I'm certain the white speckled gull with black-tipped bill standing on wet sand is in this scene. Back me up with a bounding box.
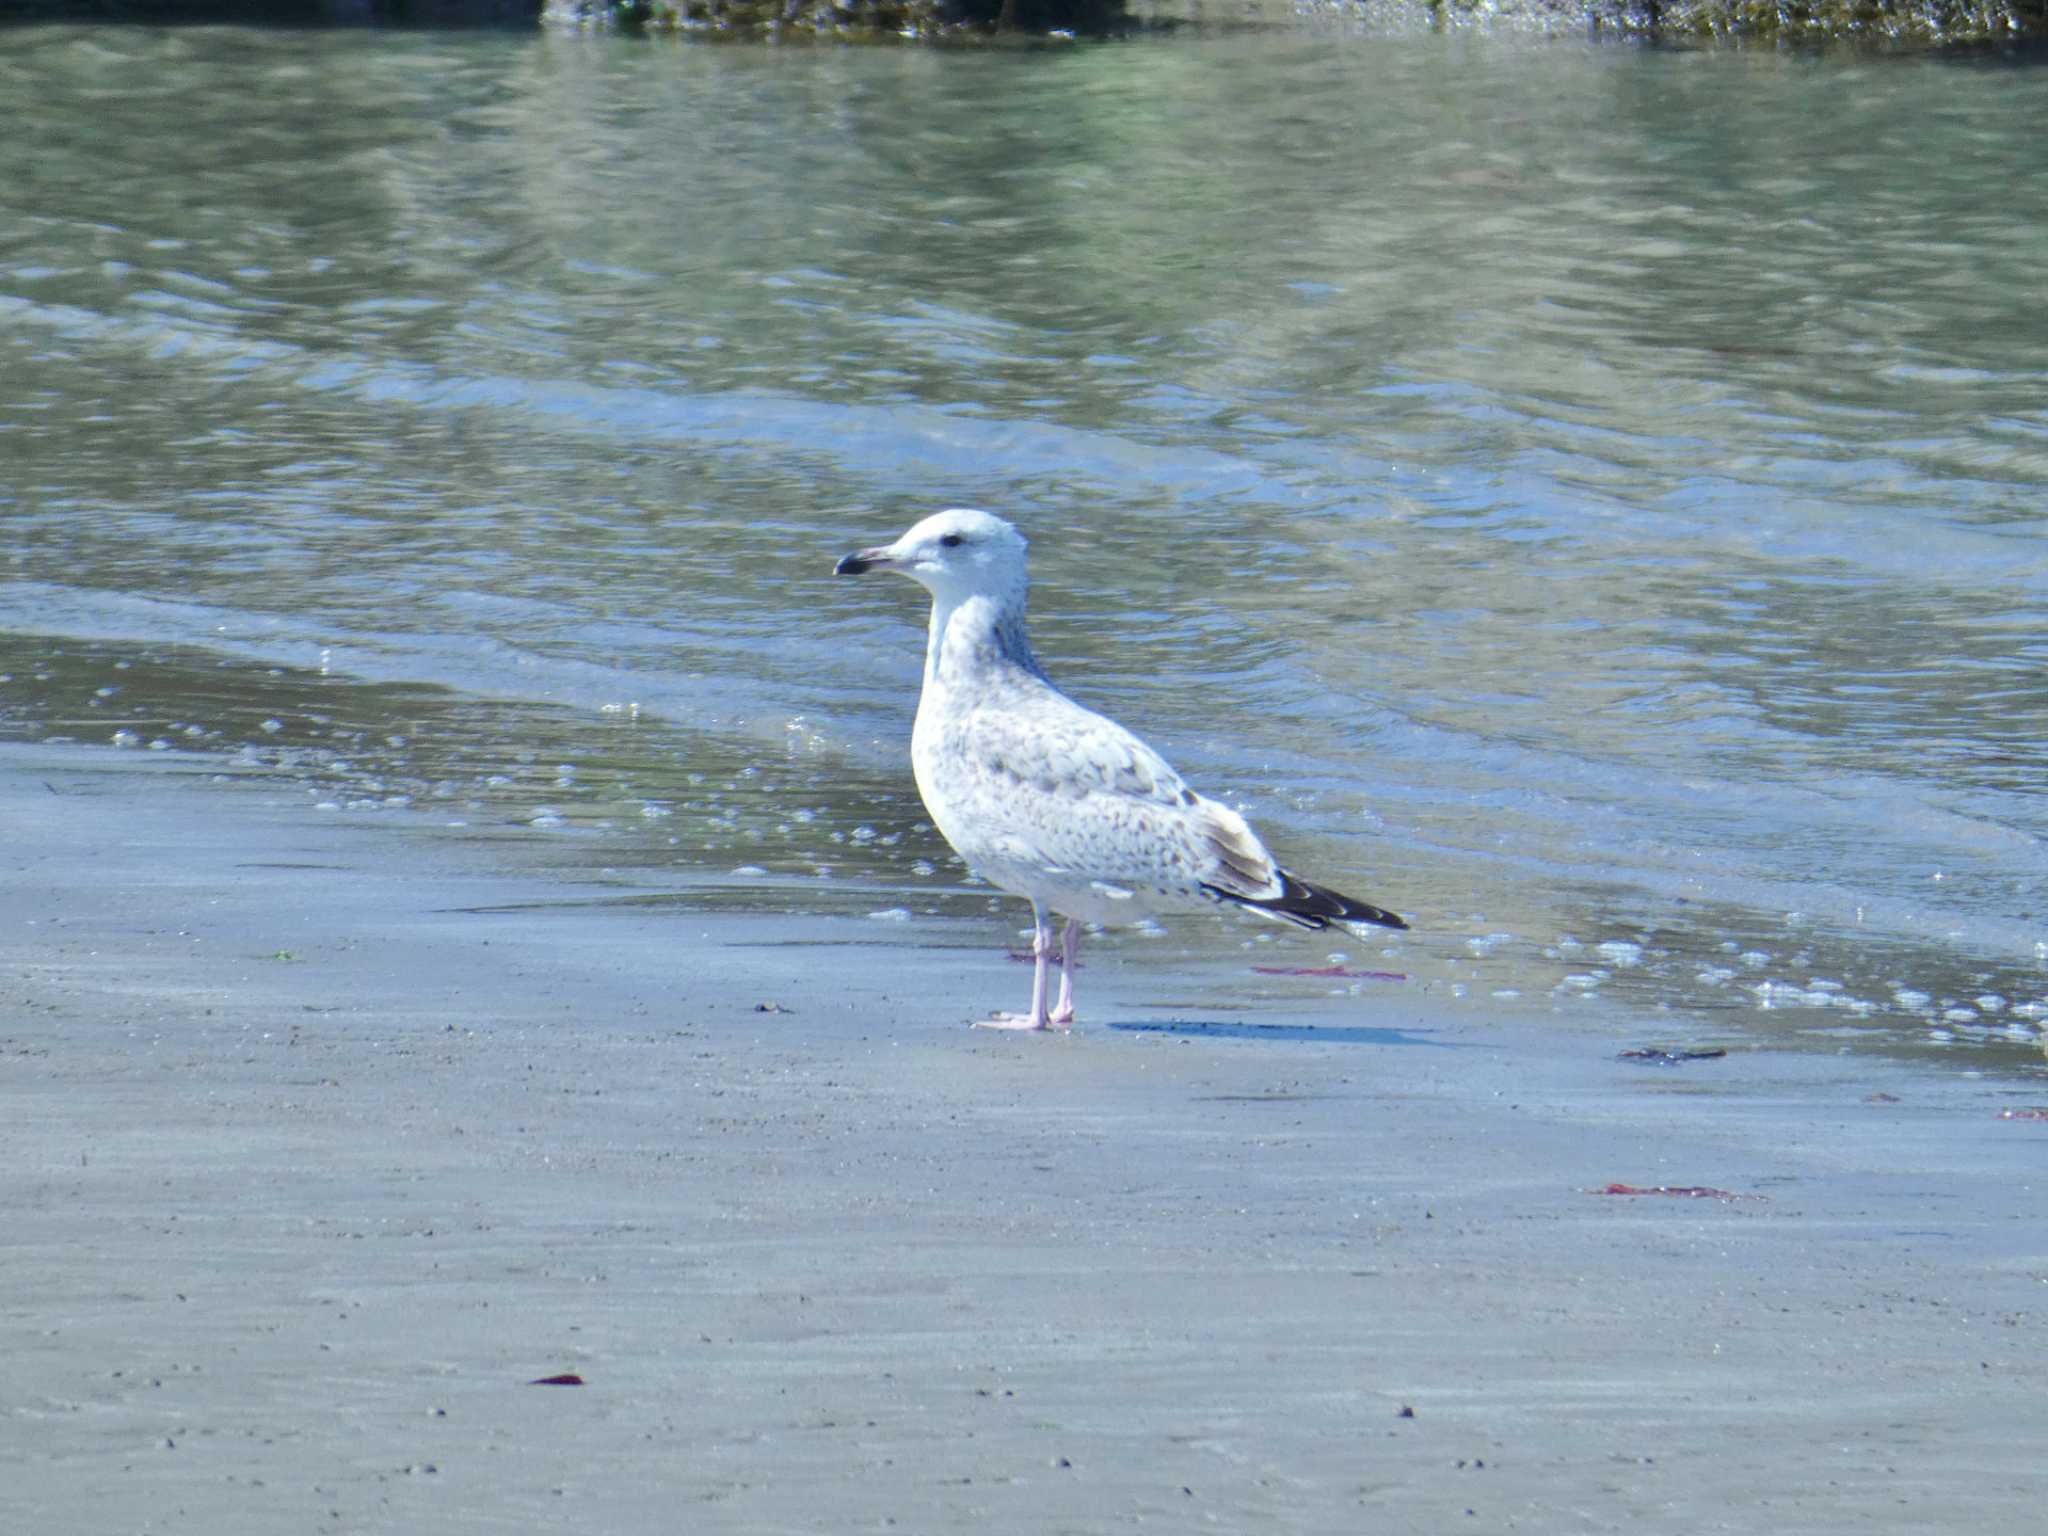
[834,508,1407,1030]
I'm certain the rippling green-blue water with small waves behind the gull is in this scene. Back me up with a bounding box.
[0,27,2048,1065]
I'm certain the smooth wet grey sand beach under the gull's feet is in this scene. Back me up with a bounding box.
[0,748,2048,1536]
